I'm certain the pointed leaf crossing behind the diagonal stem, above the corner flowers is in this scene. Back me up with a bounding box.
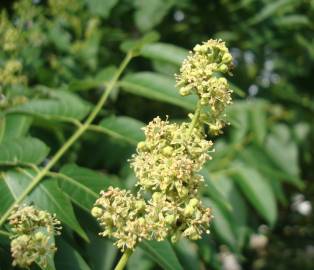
[2,169,88,240]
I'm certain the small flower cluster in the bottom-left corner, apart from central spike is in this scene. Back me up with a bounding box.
[9,206,61,268]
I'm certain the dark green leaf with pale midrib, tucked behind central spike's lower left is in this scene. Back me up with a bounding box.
[57,164,115,212]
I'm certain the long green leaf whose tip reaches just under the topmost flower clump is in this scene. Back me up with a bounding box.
[120,72,196,110]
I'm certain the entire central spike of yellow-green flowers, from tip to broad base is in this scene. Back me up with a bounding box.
[92,40,231,251]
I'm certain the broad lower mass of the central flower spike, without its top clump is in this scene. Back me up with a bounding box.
[92,117,212,251]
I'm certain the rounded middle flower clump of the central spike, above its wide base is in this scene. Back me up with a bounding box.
[131,117,212,198]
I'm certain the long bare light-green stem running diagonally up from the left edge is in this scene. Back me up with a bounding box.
[0,51,133,226]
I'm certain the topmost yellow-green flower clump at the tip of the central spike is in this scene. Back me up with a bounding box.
[176,39,232,135]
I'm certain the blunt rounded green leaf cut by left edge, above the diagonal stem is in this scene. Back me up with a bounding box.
[0,137,49,165]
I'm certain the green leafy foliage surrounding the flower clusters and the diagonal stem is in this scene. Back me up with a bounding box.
[0,0,314,270]
